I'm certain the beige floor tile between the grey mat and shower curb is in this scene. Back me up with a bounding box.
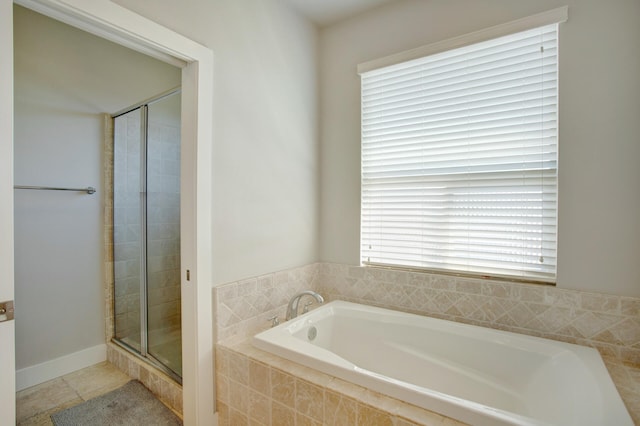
[62,361,131,401]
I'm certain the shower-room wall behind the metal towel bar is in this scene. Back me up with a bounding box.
[14,6,180,369]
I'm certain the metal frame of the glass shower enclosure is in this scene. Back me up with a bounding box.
[111,87,182,384]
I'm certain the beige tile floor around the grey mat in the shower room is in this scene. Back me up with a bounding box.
[16,361,131,426]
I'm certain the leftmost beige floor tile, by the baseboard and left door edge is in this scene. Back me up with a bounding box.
[16,378,82,422]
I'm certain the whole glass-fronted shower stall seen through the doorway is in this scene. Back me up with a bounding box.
[112,89,182,382]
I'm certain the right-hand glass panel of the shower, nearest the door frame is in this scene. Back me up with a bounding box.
[147,94,182,376]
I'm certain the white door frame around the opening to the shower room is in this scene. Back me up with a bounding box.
[0,0,215,424]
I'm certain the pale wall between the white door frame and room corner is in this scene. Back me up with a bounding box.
[115,0,318,285]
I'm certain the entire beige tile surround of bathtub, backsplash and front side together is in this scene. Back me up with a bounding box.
[213,263,640,425]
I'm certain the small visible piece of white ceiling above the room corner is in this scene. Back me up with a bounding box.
[287,0,397,27]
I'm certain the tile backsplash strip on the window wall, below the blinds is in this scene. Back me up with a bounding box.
[318,264,640,365]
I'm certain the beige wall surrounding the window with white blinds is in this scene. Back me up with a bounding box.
[320,0,640,296]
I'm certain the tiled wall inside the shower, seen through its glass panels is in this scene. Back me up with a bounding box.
[114,114,180,349]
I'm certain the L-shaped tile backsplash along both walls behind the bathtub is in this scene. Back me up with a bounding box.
[214,263,640,365]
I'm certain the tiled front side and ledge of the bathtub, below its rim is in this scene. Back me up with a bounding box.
[216,343,461,426]
